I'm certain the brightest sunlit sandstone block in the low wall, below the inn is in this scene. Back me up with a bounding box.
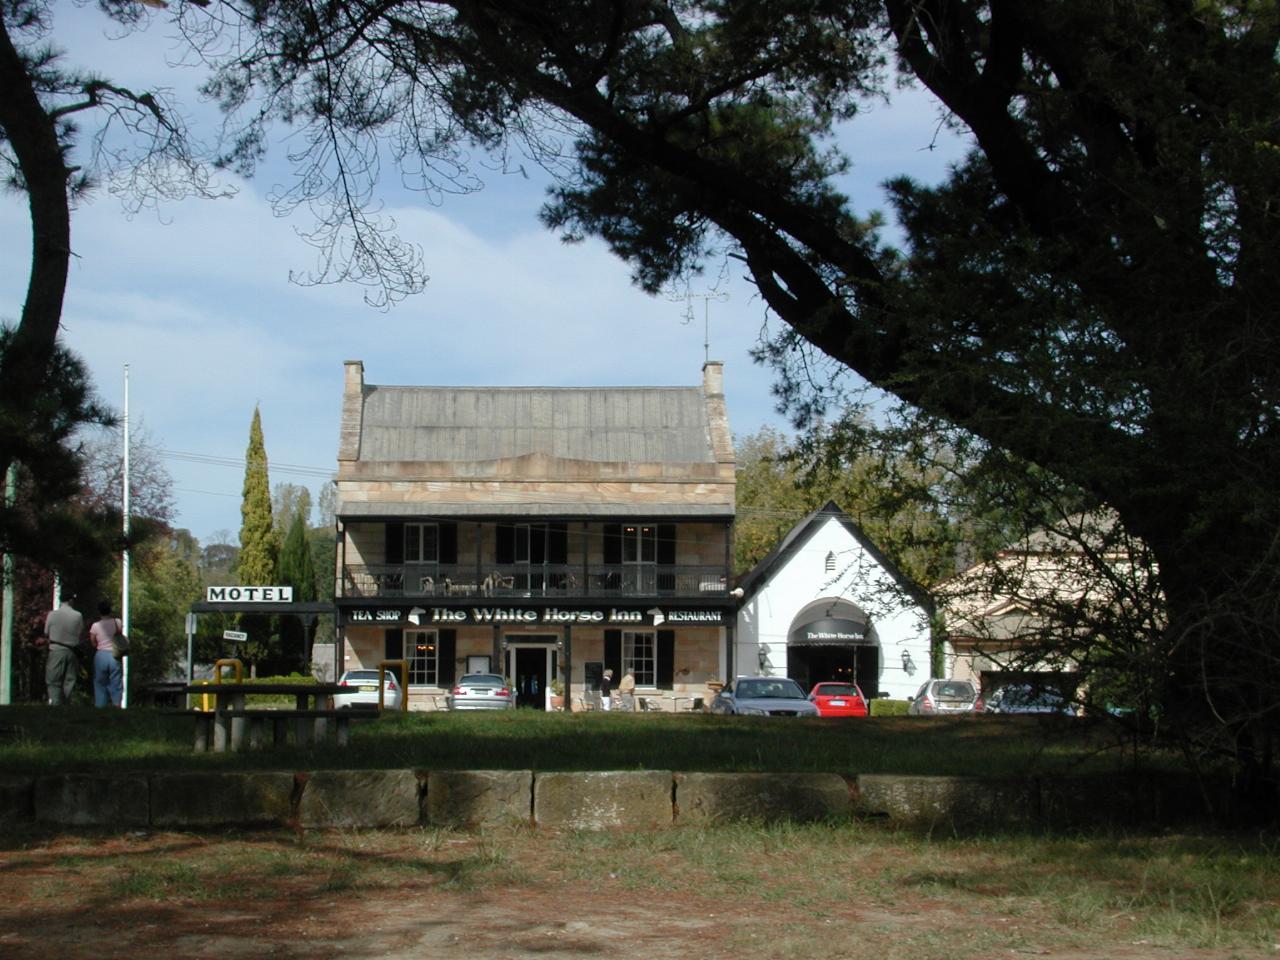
[534,771,675,829]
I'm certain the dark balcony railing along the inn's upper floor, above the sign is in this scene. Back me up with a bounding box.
[342,563,728,598]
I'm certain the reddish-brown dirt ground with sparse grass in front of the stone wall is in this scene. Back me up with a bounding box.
[0,833,1280,960]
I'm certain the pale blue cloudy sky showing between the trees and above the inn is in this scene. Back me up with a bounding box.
[0,3,961,541]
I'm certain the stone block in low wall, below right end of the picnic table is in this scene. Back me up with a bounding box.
[298,771,421,827]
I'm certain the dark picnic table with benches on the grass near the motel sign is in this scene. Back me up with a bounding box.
[172,682,378,753]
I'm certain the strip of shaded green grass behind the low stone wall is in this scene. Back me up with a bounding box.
[0,707,1174,777]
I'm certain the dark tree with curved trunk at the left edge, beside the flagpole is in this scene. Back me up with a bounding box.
[0,0,211,570]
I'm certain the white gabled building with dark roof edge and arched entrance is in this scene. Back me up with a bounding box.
[733,502,933,699]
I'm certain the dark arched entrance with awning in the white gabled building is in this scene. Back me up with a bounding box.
[787,598,881,698]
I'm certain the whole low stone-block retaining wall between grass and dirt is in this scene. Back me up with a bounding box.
[0,769,1218,829]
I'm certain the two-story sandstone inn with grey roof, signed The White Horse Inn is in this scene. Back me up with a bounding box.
[337,361,735,709]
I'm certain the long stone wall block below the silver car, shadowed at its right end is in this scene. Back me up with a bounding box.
[856,773,1039,828]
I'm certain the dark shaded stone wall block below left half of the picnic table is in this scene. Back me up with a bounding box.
[151,771,294,827]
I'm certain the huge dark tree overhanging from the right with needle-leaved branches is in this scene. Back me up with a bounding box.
[186,0,1280,803]
